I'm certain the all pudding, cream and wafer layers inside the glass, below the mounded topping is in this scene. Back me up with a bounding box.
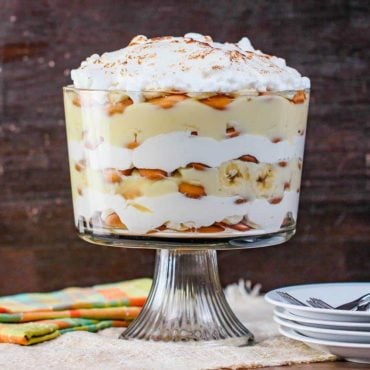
[65,89,308,237]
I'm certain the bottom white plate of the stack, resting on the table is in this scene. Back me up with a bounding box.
[279,326,370,364]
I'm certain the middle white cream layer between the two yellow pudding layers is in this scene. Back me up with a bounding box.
[68,132,304,172]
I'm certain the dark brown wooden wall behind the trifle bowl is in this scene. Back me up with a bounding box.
[0,0,370,294]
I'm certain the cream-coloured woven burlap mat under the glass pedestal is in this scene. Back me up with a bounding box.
[0,282,336,370]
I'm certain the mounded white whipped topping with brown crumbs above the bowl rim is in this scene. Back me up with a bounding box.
[71,33,310,96]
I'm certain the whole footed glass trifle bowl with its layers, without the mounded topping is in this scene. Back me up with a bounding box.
[64,32,309,345]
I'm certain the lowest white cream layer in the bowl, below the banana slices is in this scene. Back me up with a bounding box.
[74,189,299,234]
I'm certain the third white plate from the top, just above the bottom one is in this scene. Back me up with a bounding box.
[274,316,370,345]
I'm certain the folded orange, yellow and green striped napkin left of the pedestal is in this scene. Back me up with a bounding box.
[0,278,152,345]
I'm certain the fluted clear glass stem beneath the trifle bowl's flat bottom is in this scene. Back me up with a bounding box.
[122,248,253,345]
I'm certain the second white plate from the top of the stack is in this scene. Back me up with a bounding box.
[274,307,370,332]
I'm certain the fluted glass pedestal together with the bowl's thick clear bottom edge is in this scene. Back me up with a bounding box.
[79,228,295,346]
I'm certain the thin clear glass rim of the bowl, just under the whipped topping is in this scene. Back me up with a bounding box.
[63,85,311,97]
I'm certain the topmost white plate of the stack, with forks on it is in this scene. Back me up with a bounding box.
[265,283,370,323]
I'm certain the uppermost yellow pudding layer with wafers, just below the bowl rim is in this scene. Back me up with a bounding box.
[65,90,308,148]
